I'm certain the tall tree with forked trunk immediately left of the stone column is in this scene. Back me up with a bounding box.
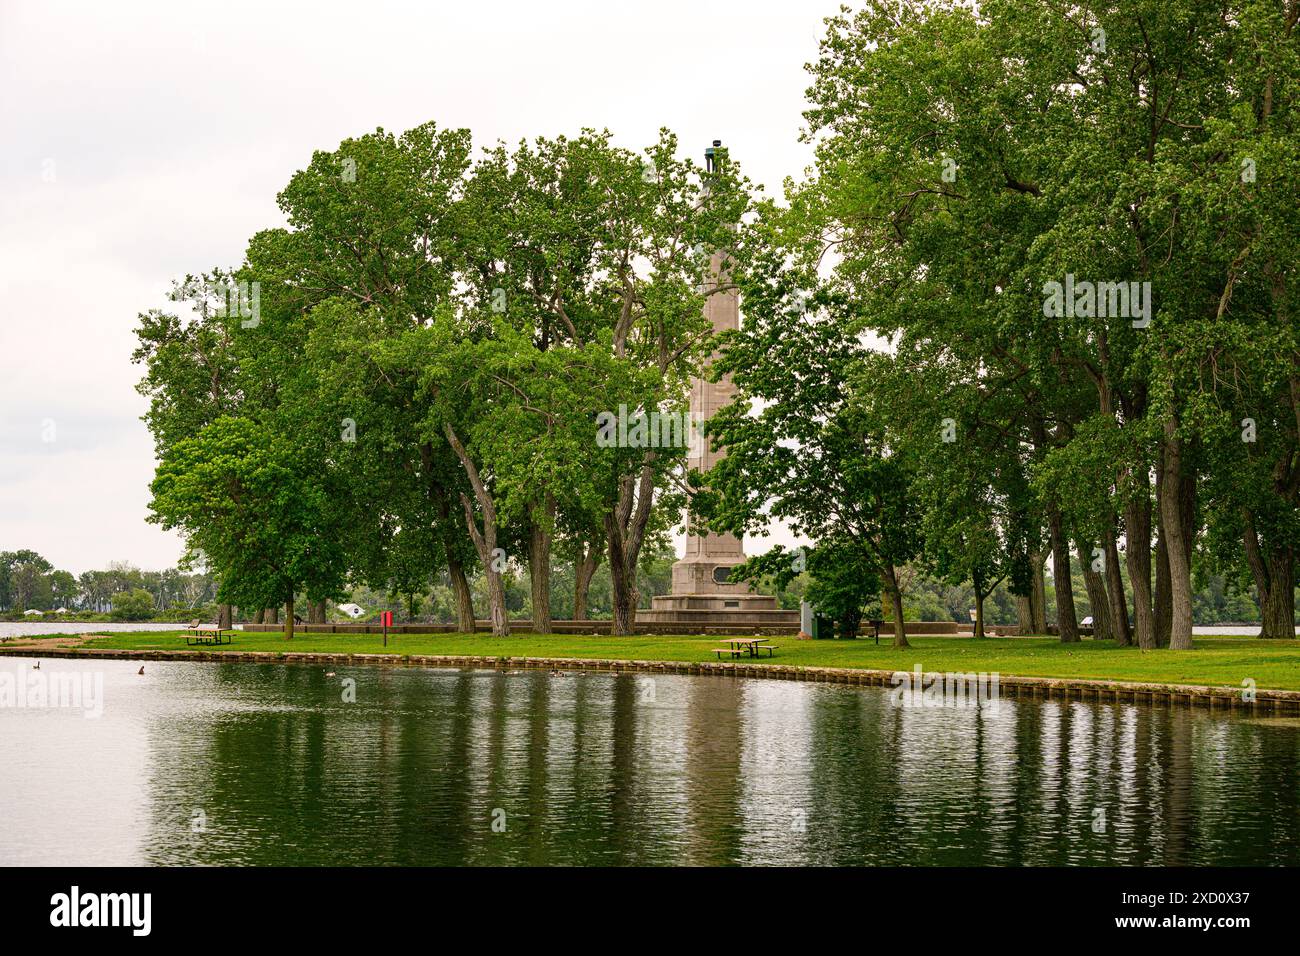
[463,130,750,633]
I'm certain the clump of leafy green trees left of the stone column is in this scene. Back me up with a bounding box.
[135,124,751,635]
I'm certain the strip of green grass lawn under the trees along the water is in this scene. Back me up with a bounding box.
[30,631,1300,691]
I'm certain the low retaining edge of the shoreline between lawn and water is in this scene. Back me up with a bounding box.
[0,646,1300,715]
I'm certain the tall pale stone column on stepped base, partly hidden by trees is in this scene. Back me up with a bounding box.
[651,139,776,611]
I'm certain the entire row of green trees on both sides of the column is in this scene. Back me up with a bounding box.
[135,0,1300,648]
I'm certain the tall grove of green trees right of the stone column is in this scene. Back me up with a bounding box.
[710,0,1300,648]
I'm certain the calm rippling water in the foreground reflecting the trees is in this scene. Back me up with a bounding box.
[0,657,1300,865]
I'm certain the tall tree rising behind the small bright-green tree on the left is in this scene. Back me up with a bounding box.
[242,124,475,632]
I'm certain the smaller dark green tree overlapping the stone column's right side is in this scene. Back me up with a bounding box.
[693,252,922,646]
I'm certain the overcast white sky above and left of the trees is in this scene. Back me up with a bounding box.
[0,0,839,572]
